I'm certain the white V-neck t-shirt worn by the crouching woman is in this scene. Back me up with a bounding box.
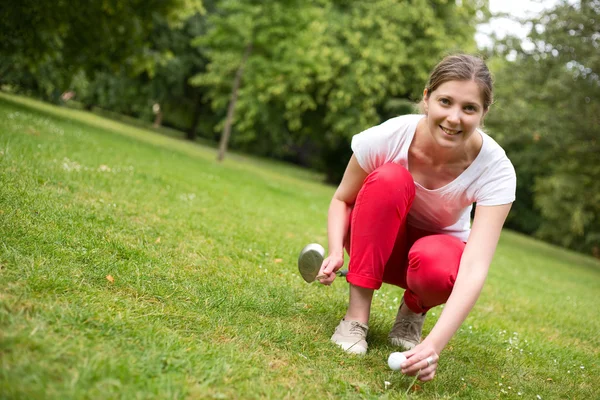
[352,115,517,242]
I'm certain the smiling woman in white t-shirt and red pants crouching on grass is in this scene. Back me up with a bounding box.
[319,55,516,381]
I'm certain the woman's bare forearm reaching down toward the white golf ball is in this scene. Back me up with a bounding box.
[425,265,487,354]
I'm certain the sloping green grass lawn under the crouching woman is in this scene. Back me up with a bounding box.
[0,90,600,399]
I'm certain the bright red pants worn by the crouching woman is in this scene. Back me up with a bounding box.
[345,164,465,312]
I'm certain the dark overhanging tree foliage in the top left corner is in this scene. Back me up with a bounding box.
[0,0,203,99]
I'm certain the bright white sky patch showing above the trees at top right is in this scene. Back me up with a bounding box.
[475,0,559,47]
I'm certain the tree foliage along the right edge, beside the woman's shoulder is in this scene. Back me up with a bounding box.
[488,0,600,255]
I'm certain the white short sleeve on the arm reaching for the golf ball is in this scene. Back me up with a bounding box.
[475,156,517,206]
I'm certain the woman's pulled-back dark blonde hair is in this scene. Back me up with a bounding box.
[420,54,494,111]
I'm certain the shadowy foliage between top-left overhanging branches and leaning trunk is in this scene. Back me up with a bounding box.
[72,14,210,131]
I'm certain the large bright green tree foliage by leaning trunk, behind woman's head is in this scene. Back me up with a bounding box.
[192,0,486,180]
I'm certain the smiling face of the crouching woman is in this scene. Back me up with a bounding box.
[423,80,485,148]
